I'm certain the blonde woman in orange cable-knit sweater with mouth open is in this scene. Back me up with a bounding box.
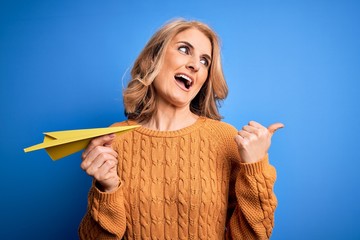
[79,20,283,240]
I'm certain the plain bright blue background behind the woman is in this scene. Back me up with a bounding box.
[0,0,360,239]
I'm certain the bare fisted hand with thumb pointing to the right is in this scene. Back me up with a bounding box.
[235,121,284,163]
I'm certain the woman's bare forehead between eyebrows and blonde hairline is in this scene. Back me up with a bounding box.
[171,28,212,56]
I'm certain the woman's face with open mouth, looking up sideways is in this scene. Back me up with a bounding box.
[153,28,212,107]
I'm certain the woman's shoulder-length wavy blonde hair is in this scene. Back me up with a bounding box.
[123,19,228,122]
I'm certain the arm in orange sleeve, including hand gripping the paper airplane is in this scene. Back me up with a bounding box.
[79,135,126,240]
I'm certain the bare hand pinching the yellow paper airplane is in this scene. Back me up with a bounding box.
[80,134,120,192]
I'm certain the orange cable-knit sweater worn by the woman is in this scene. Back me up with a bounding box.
[79,117,277,240]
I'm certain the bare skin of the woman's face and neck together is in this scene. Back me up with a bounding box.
[141,28,212,131]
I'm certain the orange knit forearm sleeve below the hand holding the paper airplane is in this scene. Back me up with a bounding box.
[79,183,126,240]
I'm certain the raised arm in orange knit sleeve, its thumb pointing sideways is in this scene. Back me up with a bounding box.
[226,121,284,240]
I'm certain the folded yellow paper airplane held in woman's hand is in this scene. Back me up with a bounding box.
[24,125,140,160]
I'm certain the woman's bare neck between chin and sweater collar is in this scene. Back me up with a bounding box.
[142,105,199,131]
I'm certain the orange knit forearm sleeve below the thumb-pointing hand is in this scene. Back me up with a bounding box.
[226,156,277,240]
